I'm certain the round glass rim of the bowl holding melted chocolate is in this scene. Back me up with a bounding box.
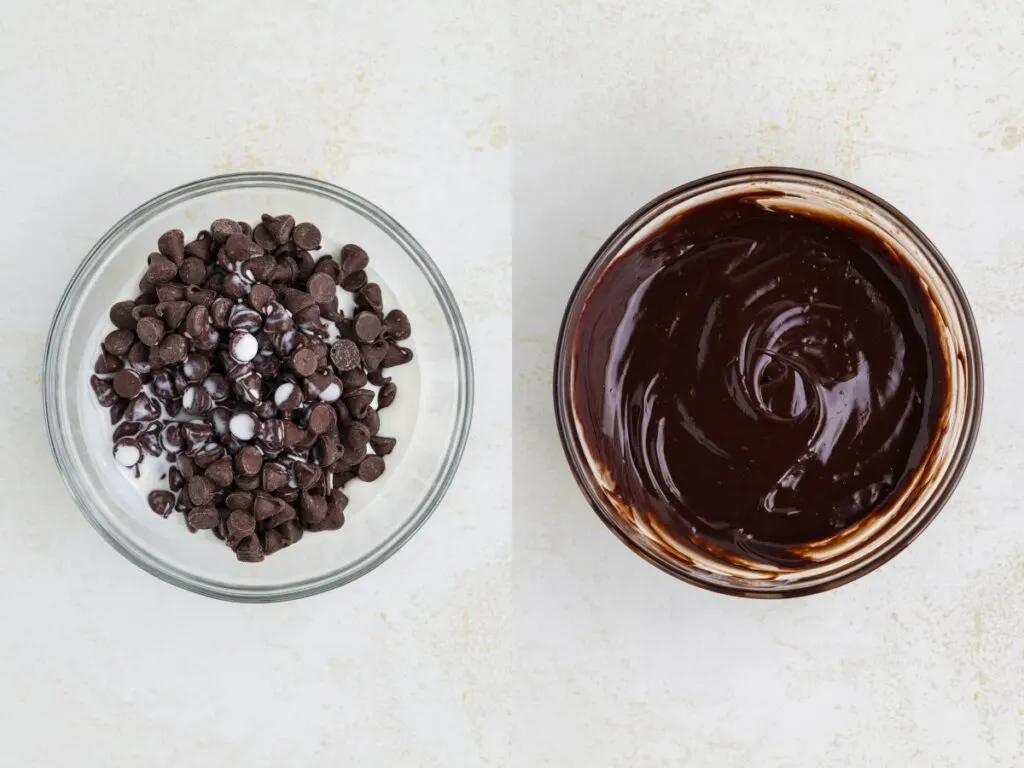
[552,166,985,599]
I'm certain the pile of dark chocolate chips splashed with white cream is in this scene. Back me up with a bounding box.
[91,214,413,562]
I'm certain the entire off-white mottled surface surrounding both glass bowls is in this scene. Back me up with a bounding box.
[0,0,1024,768]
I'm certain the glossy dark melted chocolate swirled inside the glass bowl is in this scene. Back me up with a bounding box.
[572,198,948,566]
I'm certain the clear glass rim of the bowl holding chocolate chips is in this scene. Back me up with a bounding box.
[43,172,474,602]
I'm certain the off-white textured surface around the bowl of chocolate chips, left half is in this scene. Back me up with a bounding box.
[0,0,512,768]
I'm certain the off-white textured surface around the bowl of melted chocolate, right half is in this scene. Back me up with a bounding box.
[520,0,1024,768]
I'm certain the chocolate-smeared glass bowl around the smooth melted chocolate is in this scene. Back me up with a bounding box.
[554,168,983,597]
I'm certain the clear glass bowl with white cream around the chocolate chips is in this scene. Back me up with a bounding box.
[43,173,473,602]
